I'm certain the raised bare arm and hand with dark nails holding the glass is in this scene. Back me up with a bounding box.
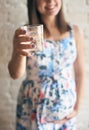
[8,28,33,79]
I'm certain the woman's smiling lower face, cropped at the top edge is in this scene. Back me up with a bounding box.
[36,0,62,16]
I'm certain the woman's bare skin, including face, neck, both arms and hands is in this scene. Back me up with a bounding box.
[8,0,85,124]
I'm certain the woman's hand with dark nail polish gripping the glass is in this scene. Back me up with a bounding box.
[13,28,35,56]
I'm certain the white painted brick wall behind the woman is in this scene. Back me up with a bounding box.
[0,0,89,130]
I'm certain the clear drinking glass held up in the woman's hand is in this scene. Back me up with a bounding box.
[22,24,43,51]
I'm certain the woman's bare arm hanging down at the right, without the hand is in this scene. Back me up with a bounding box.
[74,26,85,111]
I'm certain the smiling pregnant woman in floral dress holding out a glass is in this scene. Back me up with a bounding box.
[8,0,84,130]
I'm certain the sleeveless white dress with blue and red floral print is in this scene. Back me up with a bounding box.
[16,26,77,130]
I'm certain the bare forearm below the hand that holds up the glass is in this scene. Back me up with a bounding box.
[8,53,26,79]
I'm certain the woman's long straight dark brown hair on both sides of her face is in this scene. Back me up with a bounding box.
[27,0,71,33]
